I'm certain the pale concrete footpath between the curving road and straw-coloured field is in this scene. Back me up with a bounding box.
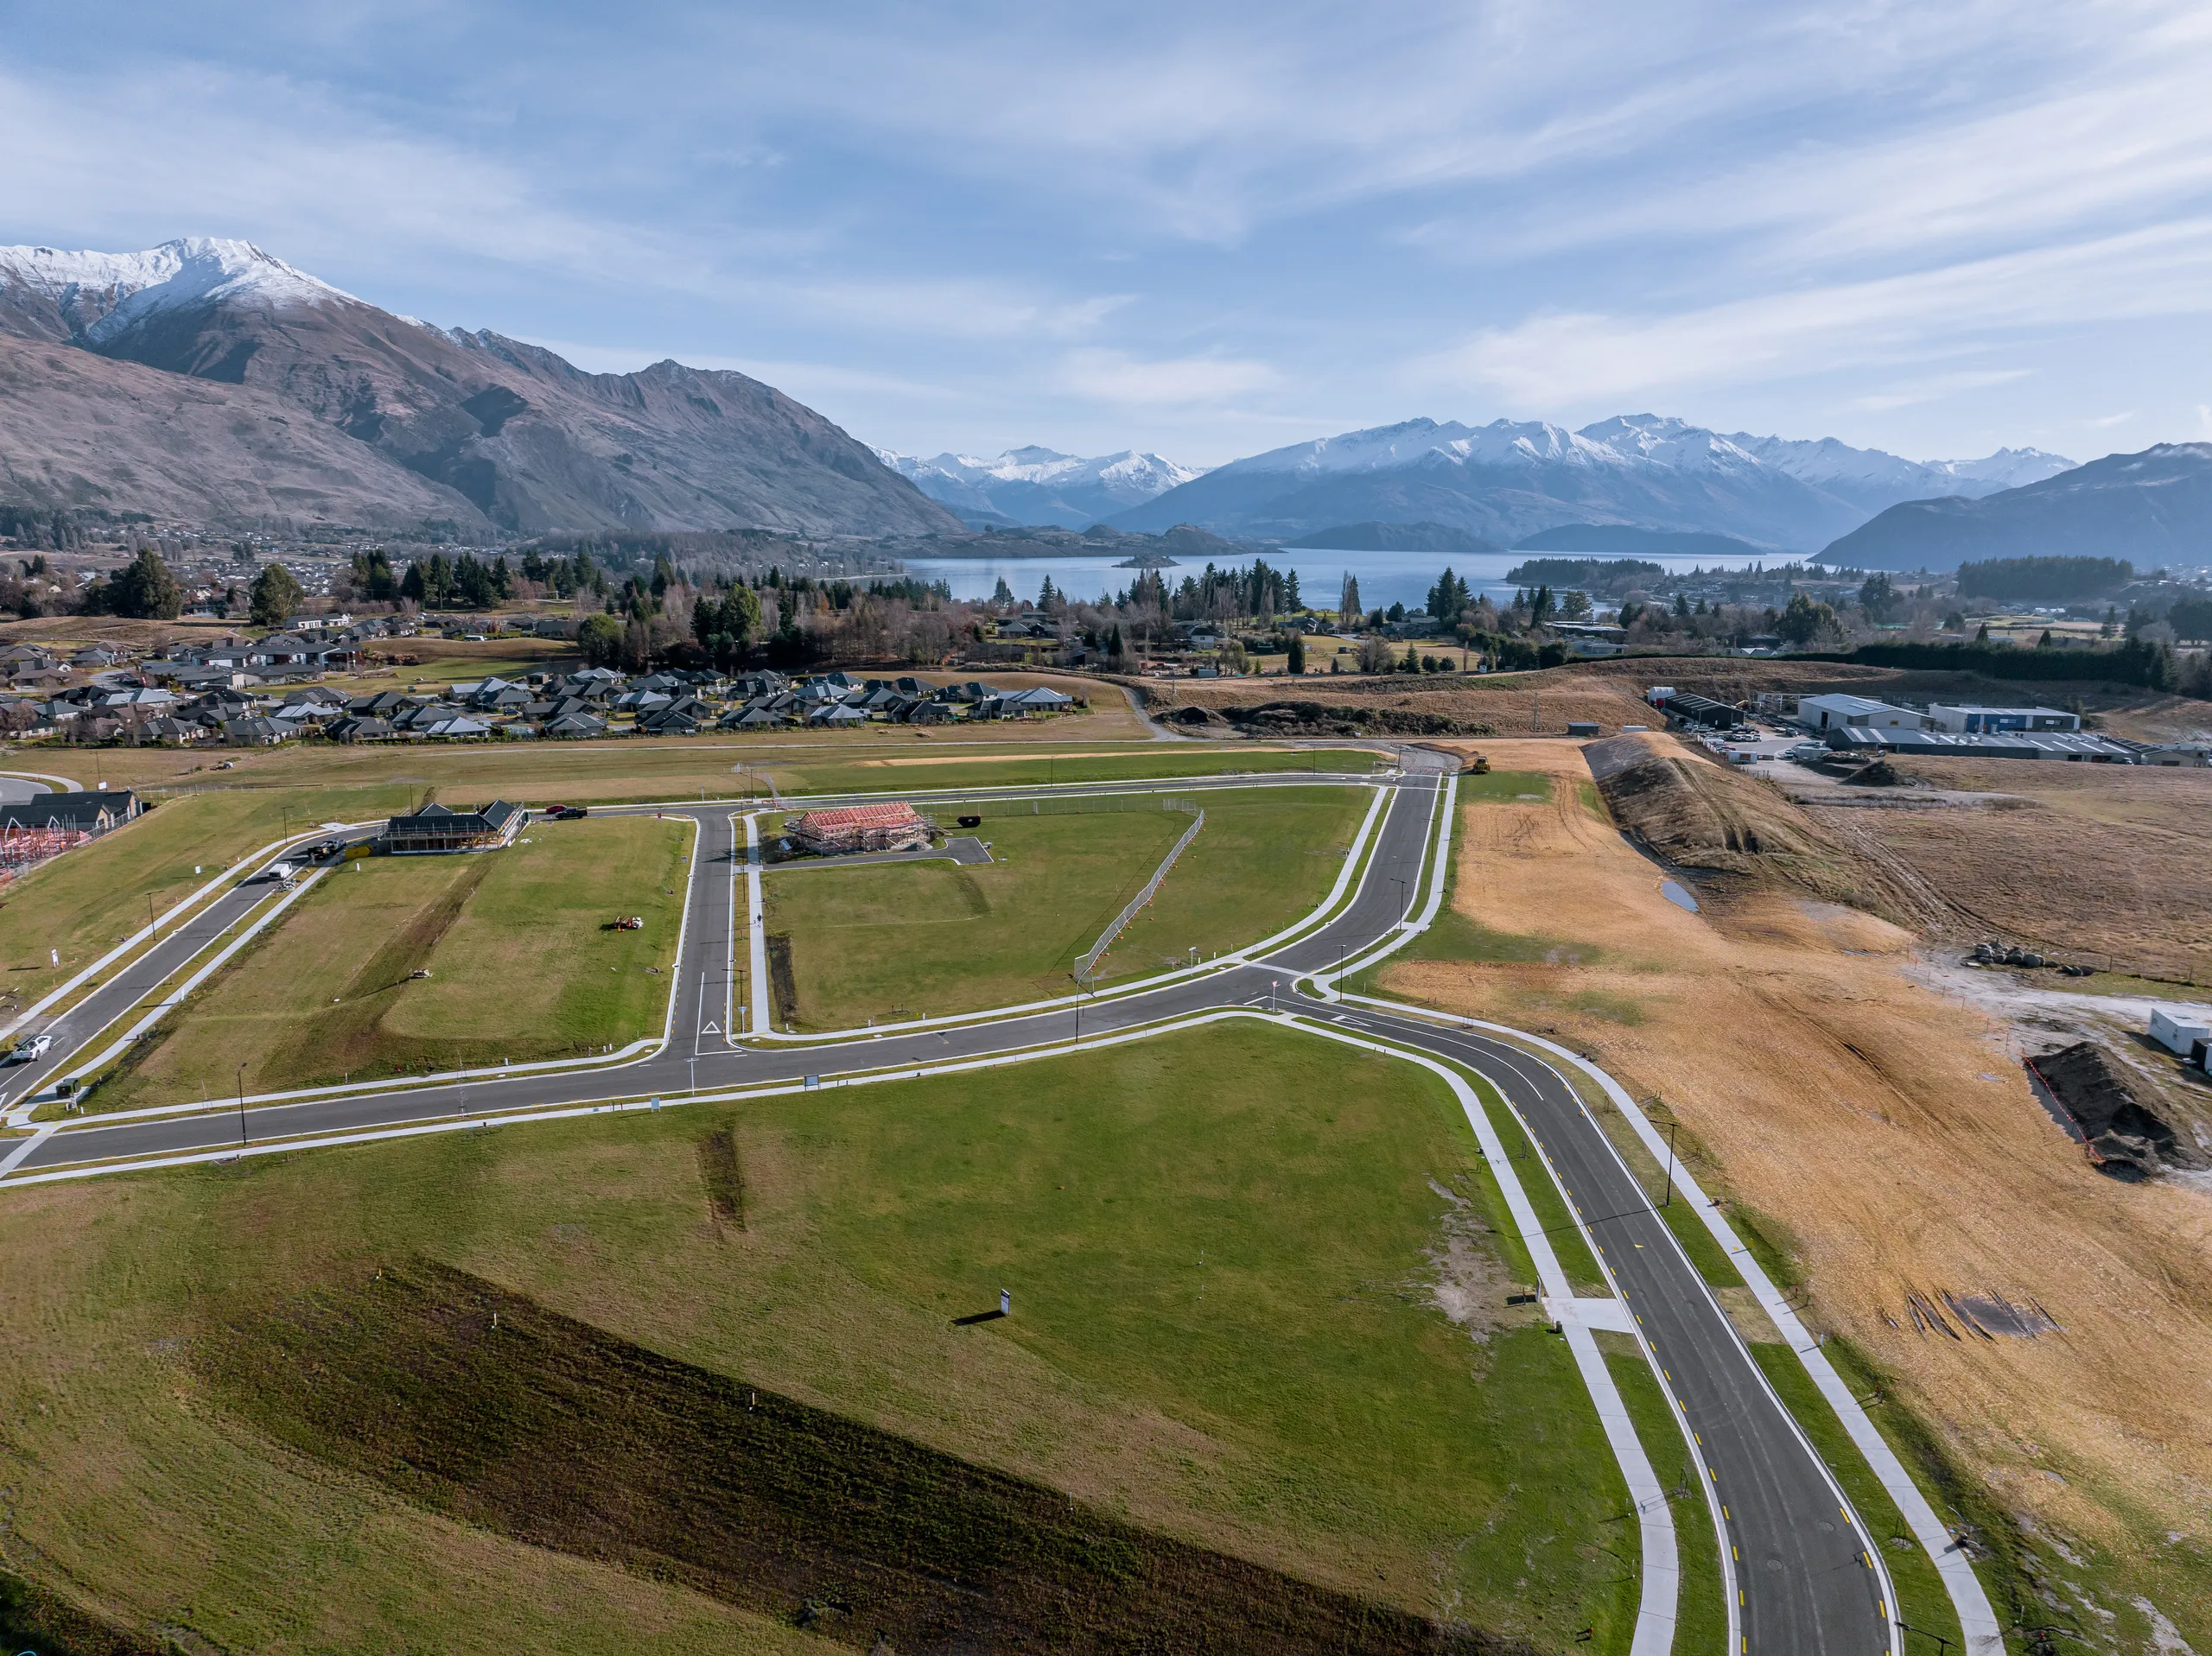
[1344,995,2004,1656]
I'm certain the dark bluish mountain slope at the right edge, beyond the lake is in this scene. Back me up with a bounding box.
[1821,442,2212,570]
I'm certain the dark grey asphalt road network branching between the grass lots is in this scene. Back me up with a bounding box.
[17,774,1891,1656]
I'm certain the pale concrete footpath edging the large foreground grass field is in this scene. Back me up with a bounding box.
[0,1008,1679,1656]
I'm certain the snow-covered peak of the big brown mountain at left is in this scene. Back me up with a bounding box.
[0,237,352,345]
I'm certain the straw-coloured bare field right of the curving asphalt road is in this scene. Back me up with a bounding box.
[1382,743,2212,1649]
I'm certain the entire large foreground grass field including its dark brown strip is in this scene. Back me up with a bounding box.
[0,1028,1637,1652]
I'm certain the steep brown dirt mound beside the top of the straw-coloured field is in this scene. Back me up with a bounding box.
[1584,736,1913,920]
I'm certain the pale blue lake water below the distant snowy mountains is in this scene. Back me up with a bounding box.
[907,549,1712,610]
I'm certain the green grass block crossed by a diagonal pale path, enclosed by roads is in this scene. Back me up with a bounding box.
[763,787,1370,1031]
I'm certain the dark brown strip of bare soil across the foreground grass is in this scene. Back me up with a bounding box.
[194,1262,1529,1656]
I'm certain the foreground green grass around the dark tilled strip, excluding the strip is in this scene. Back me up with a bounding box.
[0,1026,1637,1652]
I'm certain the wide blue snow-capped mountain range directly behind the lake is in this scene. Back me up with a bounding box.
[1110,414,2073,555]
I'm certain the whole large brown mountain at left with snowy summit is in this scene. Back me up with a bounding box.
[0,238,960,535]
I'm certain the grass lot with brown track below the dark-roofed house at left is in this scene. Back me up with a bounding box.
[86,815,690,1110]
